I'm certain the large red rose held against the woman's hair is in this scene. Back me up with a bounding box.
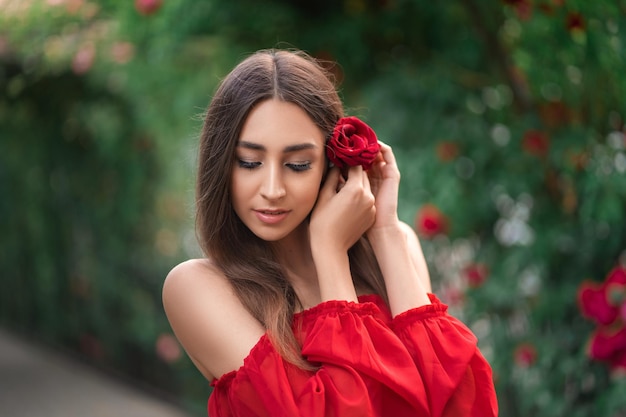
[326,117,380,170]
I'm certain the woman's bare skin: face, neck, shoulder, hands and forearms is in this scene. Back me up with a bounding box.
[163,99,431,381]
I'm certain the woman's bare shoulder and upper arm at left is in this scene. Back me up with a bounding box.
[163,259,265,380]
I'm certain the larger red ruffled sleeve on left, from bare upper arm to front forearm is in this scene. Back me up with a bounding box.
[209,301,429,417]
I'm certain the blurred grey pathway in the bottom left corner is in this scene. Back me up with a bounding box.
[0,328,194,417]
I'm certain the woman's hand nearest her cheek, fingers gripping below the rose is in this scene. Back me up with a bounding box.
[309,166,376,252]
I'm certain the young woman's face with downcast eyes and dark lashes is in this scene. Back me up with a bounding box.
[231,99,326,241]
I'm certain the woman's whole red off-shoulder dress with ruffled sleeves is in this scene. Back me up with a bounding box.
[208,295,498,417]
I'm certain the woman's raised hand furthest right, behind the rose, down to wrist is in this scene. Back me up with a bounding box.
[368,142,400,235]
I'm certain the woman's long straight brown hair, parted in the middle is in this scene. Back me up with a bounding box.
[196,50,386,368]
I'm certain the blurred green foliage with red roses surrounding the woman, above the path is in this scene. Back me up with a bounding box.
[0,0,626,417]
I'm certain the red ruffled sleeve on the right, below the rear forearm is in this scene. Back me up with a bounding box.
[390,294,498,417]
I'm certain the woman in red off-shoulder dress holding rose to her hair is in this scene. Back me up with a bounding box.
[163,50,497,417]
